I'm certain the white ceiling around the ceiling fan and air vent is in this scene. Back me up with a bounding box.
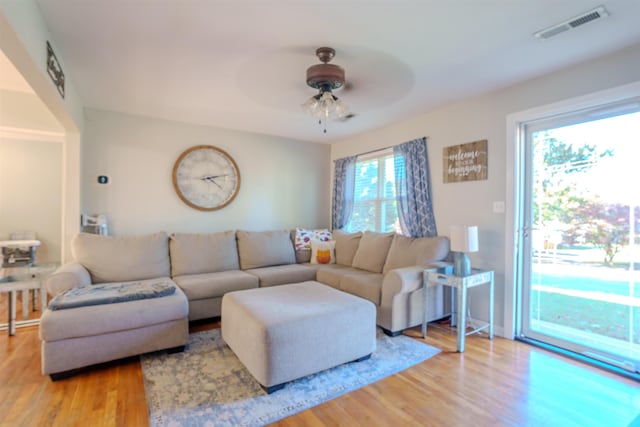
[28,0,640,142]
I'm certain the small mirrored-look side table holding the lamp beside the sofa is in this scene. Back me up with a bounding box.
[422,268,493,353]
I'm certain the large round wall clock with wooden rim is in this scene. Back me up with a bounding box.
[173,145,240,211]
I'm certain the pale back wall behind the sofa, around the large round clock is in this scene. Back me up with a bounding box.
[82,109,330,235]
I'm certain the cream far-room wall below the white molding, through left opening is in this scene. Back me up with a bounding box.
[0,136,62,262]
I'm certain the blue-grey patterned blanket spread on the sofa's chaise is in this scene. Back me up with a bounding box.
[49,280,176,310]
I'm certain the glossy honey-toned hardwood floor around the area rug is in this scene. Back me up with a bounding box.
[0,301,640,427]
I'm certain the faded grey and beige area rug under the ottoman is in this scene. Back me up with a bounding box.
[141,329,440,427]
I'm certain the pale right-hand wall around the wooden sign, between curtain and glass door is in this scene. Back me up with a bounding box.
[331,44,640,332]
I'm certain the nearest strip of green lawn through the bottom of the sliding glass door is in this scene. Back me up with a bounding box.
[531,291,640,344]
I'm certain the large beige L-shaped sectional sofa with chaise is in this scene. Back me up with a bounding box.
[40,230,449,376]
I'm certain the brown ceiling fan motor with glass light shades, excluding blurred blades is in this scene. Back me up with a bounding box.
[302,47,349,133]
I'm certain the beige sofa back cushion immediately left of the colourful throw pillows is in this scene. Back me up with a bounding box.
[236,230,296,270]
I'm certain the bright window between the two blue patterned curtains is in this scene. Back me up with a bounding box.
[345,149,401,233]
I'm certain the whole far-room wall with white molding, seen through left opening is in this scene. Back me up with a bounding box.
[0,90,64,262]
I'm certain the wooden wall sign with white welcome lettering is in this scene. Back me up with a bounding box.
[442,139,488,183]
